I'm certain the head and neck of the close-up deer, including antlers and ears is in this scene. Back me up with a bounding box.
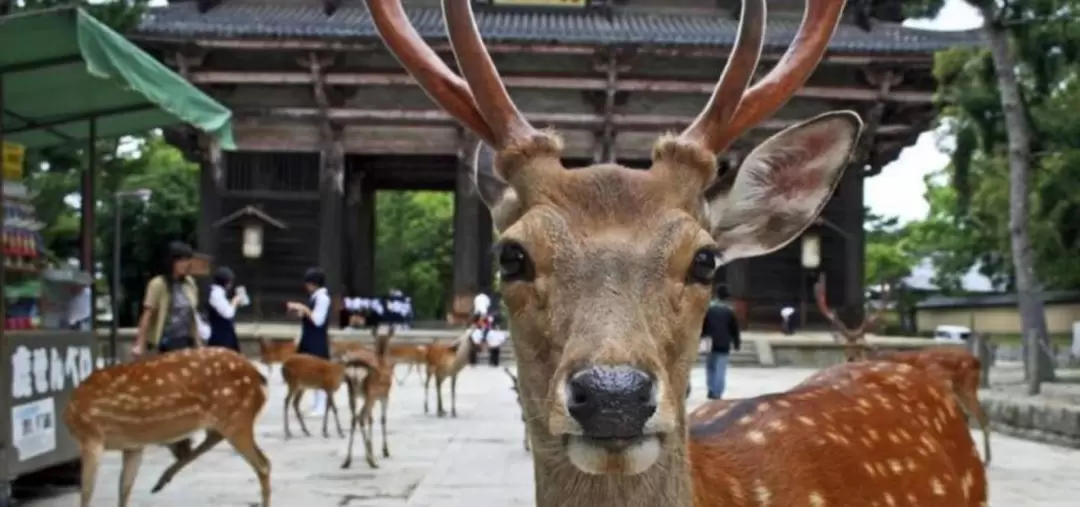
[367,0,862,499]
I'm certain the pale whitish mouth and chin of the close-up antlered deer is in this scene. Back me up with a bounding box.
[564,433,663,476]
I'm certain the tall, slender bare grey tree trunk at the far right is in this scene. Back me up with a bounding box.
[975,0,1054,395]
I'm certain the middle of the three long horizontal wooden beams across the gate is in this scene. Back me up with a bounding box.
[191,70,934,104]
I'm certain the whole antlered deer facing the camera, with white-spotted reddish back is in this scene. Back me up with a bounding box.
[367,0,986,507]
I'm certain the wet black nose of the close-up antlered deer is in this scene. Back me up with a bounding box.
[566,365,657,439]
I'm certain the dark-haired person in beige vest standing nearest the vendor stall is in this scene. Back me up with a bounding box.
[131,241,202,357]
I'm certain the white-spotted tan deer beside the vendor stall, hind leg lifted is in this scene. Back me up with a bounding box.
[64,347,270,507]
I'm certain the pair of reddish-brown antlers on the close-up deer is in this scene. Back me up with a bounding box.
[366,0,843,152]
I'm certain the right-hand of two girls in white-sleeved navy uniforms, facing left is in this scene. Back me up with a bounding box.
[286,268,330,415]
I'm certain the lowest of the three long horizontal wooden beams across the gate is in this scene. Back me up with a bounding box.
[233,107,917,135]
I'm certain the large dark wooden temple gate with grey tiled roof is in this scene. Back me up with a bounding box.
[133,0,977,326]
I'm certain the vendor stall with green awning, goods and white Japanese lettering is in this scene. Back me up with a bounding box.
[0,8,233,499]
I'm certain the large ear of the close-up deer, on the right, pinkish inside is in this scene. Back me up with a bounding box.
[707,111,863,261]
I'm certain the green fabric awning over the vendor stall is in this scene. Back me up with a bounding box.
[0,8,235,149]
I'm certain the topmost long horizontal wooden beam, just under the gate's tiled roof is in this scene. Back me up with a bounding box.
[132,35,934,67]
